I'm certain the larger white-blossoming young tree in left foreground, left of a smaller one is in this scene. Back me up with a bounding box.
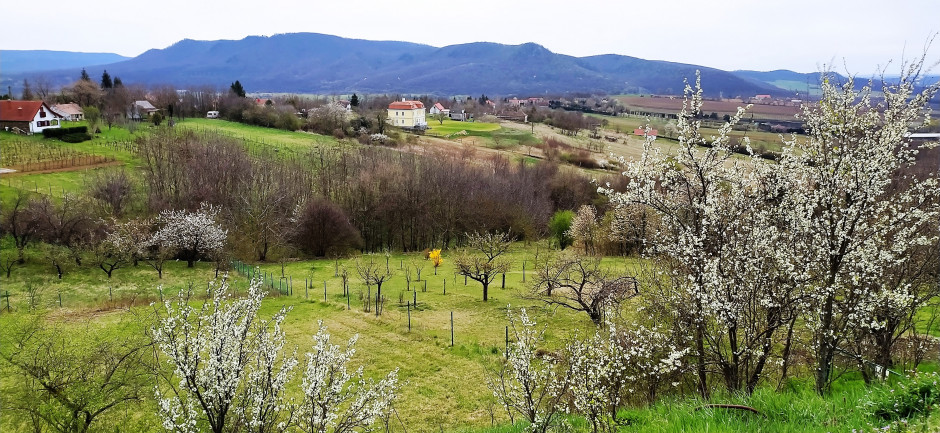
[151,279,297,433]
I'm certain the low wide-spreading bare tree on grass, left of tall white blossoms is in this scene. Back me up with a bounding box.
[532,253,638,325]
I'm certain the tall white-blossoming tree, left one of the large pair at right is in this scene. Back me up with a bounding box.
[604,73,800,396]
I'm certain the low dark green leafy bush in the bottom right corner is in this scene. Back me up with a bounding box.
[866,373,940,421]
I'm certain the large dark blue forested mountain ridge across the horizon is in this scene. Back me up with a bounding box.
[4,33,790,96]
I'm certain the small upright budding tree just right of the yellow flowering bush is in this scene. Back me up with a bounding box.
[454,232,512,301]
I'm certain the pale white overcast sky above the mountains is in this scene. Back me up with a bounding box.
[0,0,940,75]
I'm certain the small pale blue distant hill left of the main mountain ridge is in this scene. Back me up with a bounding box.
[0,50,130,75]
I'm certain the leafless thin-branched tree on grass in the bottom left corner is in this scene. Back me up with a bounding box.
[0,316,150,433]
